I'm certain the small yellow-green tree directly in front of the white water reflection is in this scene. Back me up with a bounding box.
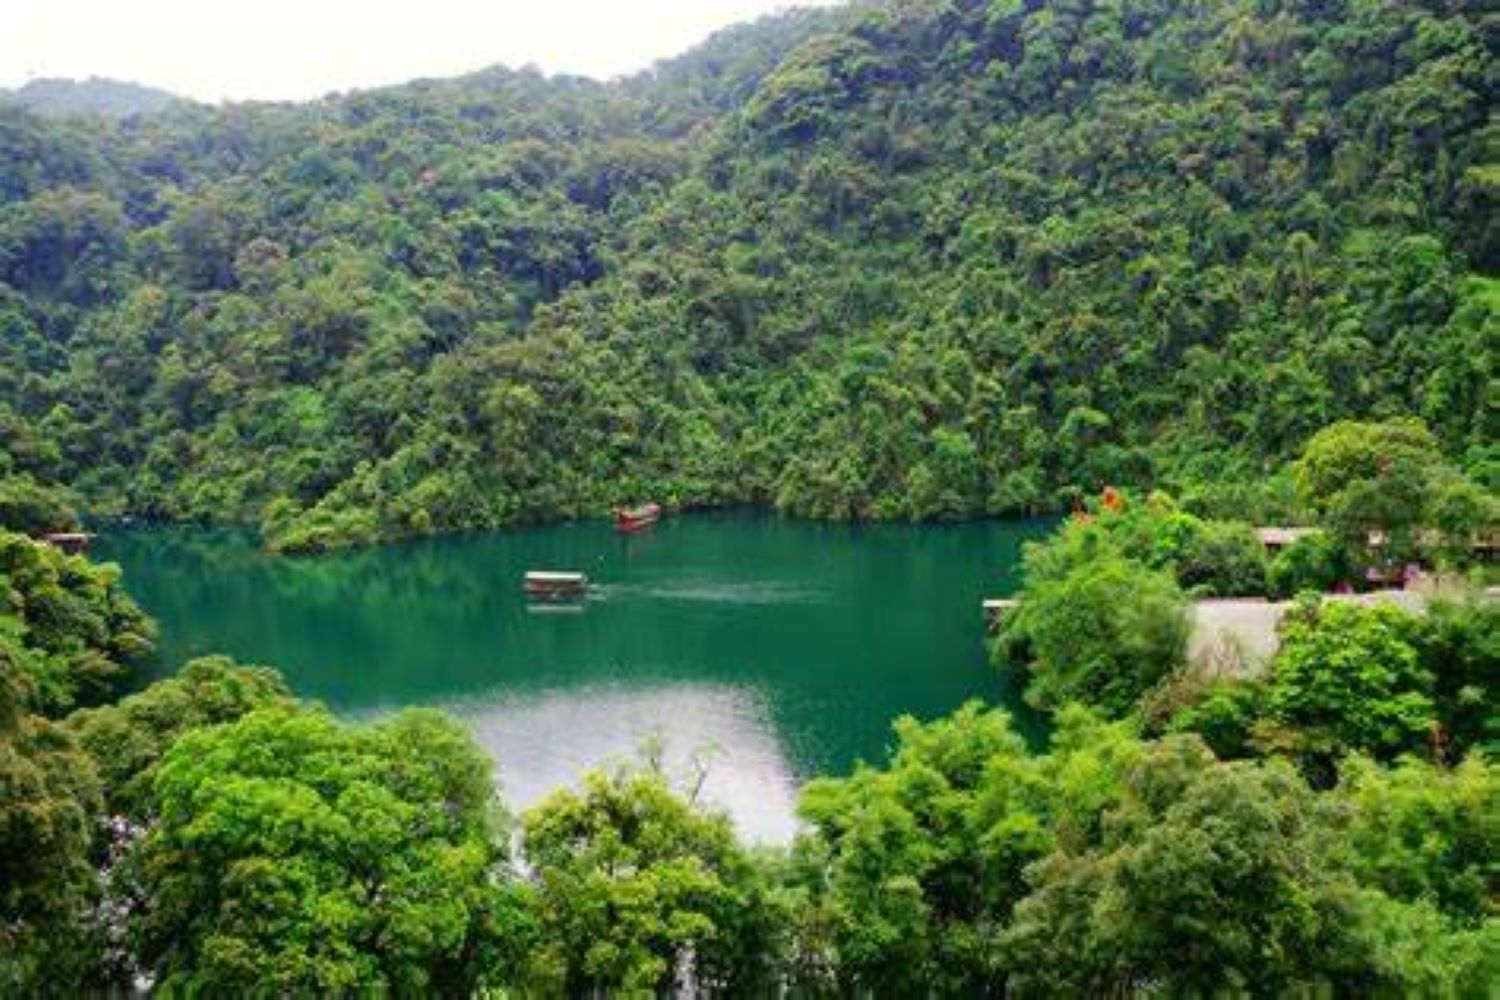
[524,771,780,996]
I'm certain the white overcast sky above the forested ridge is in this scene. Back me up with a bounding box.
[0,0,830,100]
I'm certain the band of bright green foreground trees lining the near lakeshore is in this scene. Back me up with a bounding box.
[0,501,1500,997]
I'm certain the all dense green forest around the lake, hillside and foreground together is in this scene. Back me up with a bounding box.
[0,0,1500,997]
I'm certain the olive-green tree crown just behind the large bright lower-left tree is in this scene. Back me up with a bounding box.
[68,657,291,822]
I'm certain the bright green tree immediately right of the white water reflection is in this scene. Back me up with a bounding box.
[798,703,1050,996]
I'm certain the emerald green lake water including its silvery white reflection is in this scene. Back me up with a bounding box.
[96,513,1049,841]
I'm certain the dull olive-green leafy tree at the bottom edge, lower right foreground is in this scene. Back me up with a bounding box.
[1005,738,1338,993]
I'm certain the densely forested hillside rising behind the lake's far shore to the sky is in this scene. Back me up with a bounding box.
[0,0,1500,549]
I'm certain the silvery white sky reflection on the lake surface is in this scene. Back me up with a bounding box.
[443,684,797,844]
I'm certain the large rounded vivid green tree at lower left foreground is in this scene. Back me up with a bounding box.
[132,709,510,994]
